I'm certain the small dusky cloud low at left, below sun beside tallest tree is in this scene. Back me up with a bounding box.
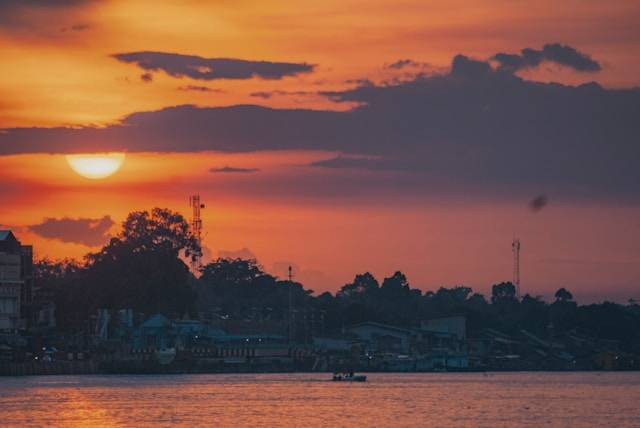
[28,215,115,247]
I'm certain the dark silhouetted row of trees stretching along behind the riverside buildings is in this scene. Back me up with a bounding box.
[36,208,640,349]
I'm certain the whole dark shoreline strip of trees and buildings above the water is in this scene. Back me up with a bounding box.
[0,207,640,375]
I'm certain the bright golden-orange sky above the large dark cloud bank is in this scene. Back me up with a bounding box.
[0,0,640,127]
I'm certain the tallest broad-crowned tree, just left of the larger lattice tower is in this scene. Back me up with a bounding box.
[86,208,201,315]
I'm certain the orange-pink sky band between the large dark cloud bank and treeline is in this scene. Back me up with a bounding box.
[0,152,640,299]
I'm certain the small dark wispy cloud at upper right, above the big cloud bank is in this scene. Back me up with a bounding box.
[491,43,602,73]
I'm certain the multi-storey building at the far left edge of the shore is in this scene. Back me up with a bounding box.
[0,230,33,331]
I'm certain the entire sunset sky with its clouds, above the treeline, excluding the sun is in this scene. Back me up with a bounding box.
[0,0,640,303]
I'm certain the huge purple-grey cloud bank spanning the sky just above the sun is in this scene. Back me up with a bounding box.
[0,55,640,202]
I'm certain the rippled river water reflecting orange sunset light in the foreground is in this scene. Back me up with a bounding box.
[0,372,640,428]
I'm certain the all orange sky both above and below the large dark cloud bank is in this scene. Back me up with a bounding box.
[0,0,640,300]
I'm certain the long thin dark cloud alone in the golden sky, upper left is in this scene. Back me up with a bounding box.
[112,51,315,80]
